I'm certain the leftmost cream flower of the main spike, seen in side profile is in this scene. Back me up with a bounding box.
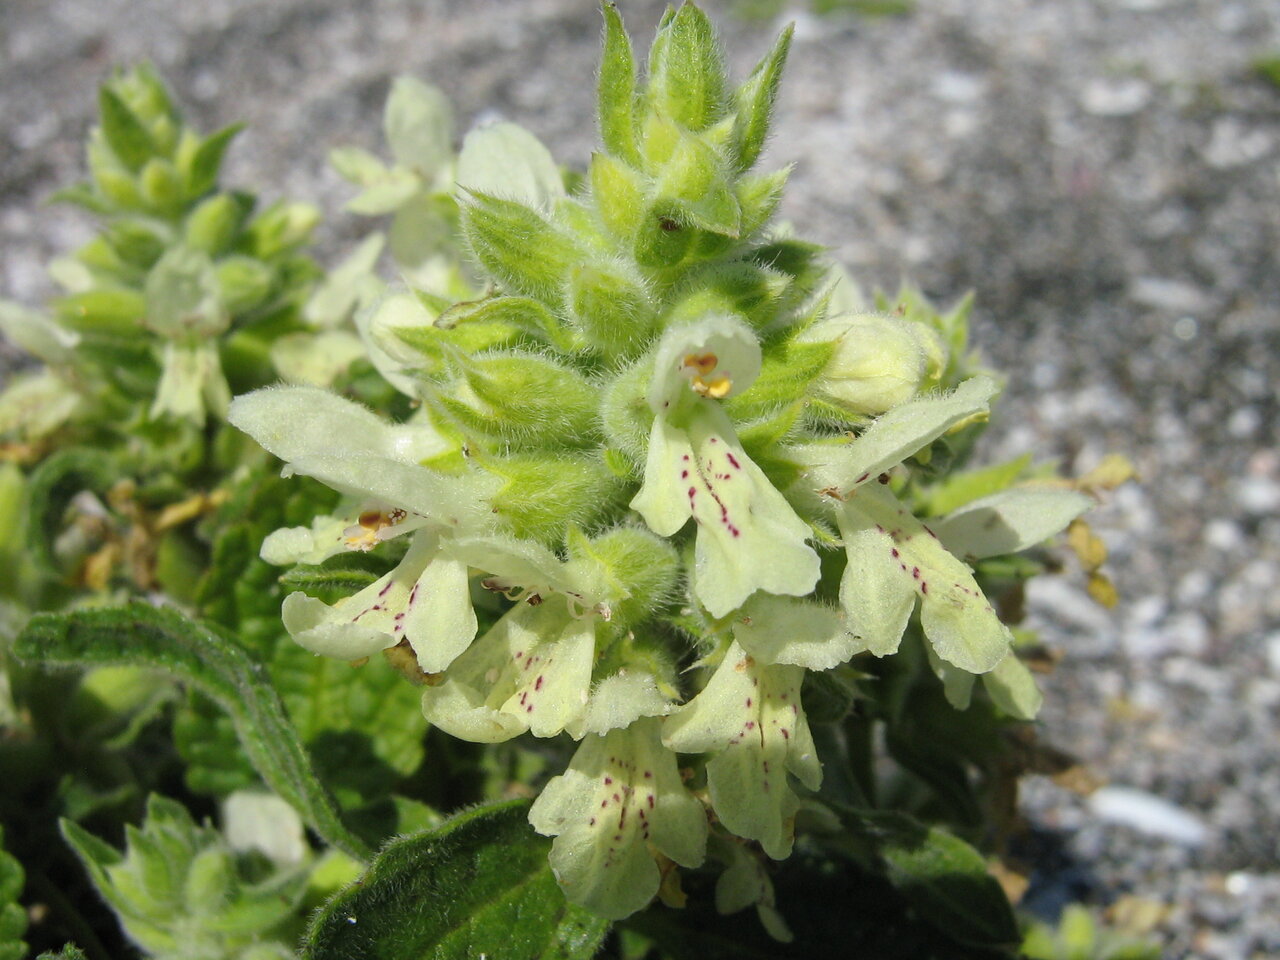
[230,387,509,673]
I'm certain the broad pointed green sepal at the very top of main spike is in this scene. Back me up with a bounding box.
[646,3,726,133]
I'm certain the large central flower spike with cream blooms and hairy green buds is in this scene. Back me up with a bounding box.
[230,4,1089,918]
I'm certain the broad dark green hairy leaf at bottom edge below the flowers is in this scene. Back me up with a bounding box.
[302,800,608,960]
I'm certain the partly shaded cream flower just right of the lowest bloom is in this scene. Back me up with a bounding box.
[662,641,822,860]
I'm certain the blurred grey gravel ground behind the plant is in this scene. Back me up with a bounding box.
[0,0,1280,960]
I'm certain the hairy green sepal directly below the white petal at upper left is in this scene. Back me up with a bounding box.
[462,193,581,310]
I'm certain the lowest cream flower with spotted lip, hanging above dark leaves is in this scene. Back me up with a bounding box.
[529,718,707,920]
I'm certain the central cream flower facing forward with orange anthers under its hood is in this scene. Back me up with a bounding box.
[631,315,819,617]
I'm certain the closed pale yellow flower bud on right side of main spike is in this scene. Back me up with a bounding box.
[801,314,928,416]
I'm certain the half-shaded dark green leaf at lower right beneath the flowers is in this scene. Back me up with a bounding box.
[881,818,1018,947]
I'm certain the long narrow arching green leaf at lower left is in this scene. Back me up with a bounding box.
[14,603,369,858]
